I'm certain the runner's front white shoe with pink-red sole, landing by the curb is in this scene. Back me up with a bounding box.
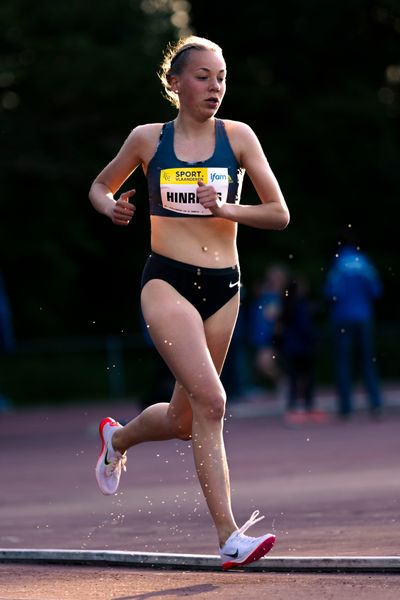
[220,510,276,571]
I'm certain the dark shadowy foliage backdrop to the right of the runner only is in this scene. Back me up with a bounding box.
[192,0,400,319]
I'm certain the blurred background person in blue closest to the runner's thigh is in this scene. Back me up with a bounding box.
[249,263,288,394]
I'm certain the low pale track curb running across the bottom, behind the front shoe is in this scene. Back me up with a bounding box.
[0,548,400,574]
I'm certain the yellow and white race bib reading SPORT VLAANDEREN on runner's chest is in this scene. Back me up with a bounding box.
[160,167,229,215]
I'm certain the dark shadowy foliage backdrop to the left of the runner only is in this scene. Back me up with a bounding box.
[0,0,175,338]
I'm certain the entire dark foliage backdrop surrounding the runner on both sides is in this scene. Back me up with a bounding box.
[0,0,400,339]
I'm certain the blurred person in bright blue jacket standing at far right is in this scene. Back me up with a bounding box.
[324,227,383,418]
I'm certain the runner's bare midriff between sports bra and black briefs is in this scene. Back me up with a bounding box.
[151,215,238,269]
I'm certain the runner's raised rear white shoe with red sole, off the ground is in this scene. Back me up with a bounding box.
[96,417,126,495]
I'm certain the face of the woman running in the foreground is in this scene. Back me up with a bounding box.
[177,50,226,118]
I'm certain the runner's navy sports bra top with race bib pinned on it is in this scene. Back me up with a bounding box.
[147,119,244,217]
